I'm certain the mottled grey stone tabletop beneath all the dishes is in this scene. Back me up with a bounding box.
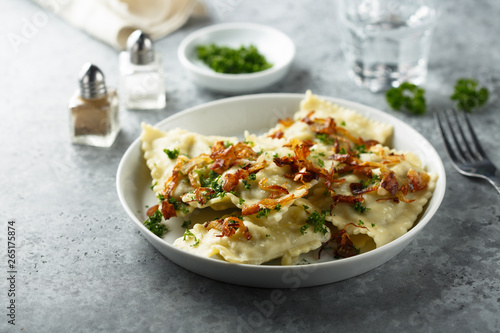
[0,0,500,332]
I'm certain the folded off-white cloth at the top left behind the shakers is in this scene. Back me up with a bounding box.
[34,0,206,50]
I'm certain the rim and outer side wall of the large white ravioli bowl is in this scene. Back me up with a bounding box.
[116,93,446,288]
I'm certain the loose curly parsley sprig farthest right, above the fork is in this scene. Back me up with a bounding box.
[450,78,489,113]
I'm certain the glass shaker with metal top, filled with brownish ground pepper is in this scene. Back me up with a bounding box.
[68,63,120,147]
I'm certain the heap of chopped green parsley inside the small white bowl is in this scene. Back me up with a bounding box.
[196,43,273,74]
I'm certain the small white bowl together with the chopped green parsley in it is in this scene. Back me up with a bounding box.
[177,23,295,94]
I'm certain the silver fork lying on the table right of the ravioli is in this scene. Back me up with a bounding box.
[434,110,500,193]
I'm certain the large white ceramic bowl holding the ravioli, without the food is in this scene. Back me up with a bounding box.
[116,94,446,288]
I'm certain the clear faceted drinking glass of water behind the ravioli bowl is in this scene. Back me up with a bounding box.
[339,0,439,92]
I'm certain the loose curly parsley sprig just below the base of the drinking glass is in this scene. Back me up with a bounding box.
[385,82,427,115]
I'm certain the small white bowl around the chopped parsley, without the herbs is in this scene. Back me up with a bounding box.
[177,23,295,93]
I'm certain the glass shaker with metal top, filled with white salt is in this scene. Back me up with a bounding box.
[119,30,166,110]
